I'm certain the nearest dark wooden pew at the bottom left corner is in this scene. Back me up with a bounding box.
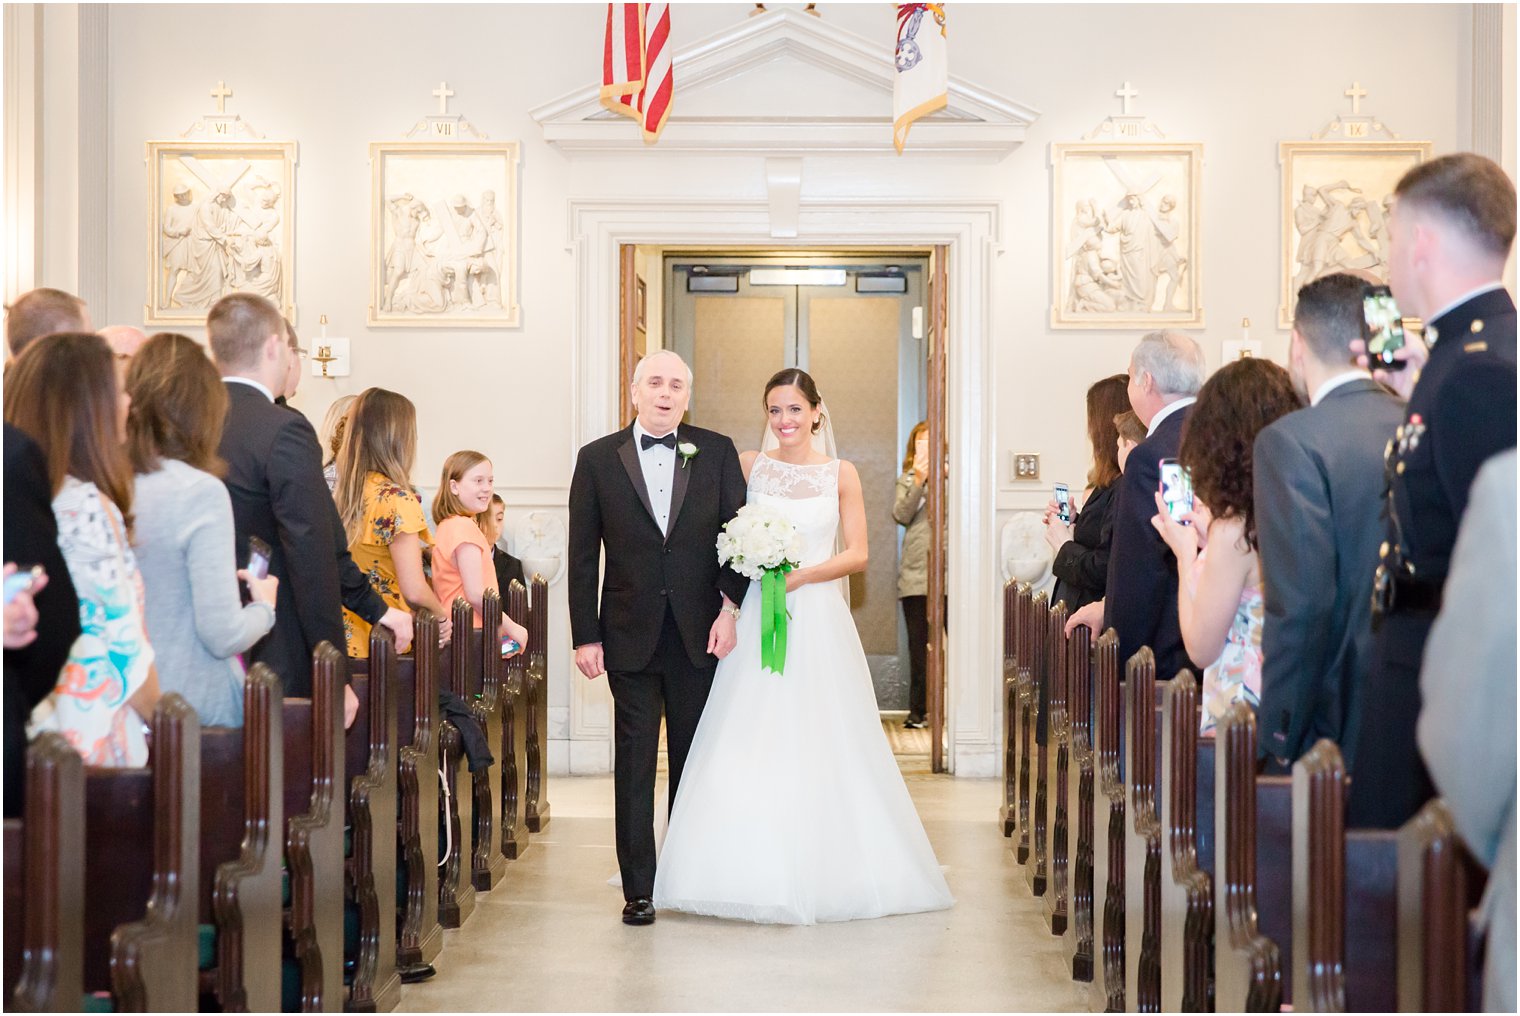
[3,733,87,1013]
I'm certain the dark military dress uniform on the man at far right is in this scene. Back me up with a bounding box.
[1347,287,1515,829]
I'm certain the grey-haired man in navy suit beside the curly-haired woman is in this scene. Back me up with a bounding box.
[1067,330,1204,680]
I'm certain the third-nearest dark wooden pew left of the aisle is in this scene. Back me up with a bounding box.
[199,663,284,1013]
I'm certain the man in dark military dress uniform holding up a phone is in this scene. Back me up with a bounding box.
[1347,152,1515,829]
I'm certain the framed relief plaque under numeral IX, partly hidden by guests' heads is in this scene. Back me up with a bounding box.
[1277,140,1430,329]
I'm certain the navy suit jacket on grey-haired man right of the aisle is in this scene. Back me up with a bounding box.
[1104,406,1193,680]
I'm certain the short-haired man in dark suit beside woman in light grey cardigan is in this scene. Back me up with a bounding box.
[207,294,412,722]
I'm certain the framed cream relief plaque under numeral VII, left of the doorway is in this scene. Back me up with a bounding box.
[368,141,520,329]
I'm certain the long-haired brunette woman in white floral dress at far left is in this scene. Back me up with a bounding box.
[5,332,160,767]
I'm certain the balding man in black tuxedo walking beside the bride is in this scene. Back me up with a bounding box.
[570,350,749,925]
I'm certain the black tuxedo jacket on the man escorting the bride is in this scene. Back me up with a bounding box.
[568,424,749,674]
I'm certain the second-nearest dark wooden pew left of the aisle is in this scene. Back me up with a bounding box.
[84,694,201,1013]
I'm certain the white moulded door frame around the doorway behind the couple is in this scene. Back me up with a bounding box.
[568,195,1002,777]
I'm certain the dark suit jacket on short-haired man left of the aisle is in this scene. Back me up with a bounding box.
[217,382,385,698]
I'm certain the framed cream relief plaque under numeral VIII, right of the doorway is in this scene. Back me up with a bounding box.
[1050,141,1204,330]
